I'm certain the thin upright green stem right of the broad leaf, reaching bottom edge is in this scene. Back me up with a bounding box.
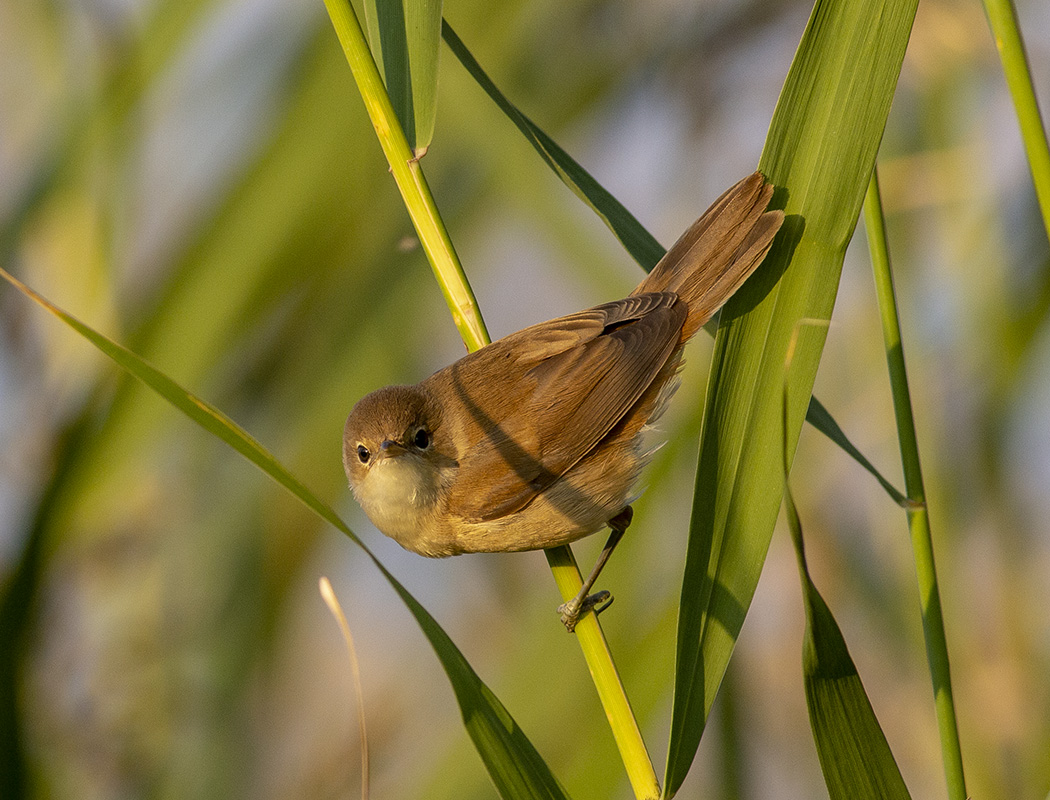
[864,172,966,800]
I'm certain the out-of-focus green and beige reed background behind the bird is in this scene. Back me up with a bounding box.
[0,0,1050,799]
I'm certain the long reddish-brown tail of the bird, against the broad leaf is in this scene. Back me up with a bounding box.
[632,172,784,341]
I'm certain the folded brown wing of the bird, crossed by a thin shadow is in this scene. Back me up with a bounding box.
[434,293,688,521]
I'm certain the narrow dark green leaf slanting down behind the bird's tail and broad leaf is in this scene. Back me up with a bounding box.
[441,21,903,503]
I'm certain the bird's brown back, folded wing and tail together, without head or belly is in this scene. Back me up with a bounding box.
[421,172,783,520]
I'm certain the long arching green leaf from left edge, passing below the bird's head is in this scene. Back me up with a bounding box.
[0,269,568,800]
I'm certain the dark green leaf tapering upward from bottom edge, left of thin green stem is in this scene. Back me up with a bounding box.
[784,485,910,800]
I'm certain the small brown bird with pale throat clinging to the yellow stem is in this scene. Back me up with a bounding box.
[342,172,783,630]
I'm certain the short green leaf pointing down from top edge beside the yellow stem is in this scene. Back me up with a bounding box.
[364,0,441,156]
